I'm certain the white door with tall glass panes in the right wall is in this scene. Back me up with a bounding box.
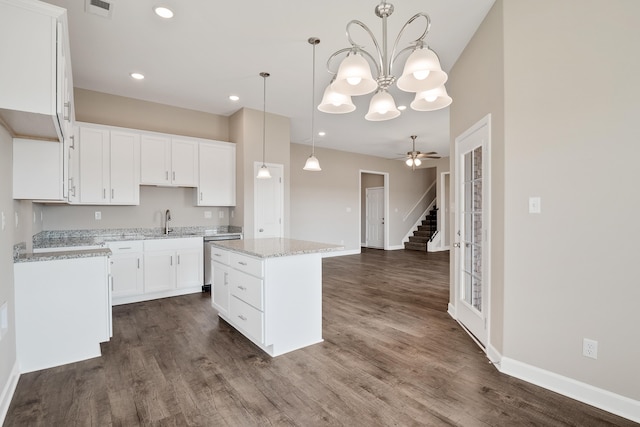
[454,116,491,346]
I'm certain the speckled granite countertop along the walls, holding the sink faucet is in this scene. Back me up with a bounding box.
[13,225,242,262]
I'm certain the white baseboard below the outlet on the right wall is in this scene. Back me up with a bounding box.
[498,357,640,423]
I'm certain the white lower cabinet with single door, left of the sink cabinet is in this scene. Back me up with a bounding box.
[107,240,144,305]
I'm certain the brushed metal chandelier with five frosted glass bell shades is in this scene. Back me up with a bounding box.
[318,0,452,121]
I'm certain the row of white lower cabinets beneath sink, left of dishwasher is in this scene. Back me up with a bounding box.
[109,237,204,305]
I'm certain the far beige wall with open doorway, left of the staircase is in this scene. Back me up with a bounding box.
[291,144,435,251]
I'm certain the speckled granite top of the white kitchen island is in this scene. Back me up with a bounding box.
[211,238,344,258]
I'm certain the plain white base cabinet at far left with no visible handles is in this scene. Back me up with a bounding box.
[14,255,111,373]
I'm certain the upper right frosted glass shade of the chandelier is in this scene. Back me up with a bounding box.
[396,47,448,92]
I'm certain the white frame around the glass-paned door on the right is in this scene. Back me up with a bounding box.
[449,114,491,353]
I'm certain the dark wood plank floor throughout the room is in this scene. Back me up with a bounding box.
[5,250,633,426]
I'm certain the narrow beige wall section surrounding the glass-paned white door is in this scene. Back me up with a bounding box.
[447,0,505,353]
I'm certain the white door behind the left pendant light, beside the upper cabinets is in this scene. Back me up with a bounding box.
[253,162,284,239]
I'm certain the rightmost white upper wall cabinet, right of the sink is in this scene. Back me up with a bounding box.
[197,141,236,206]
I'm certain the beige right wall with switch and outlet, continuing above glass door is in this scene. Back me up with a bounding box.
[449,0,640,401]
